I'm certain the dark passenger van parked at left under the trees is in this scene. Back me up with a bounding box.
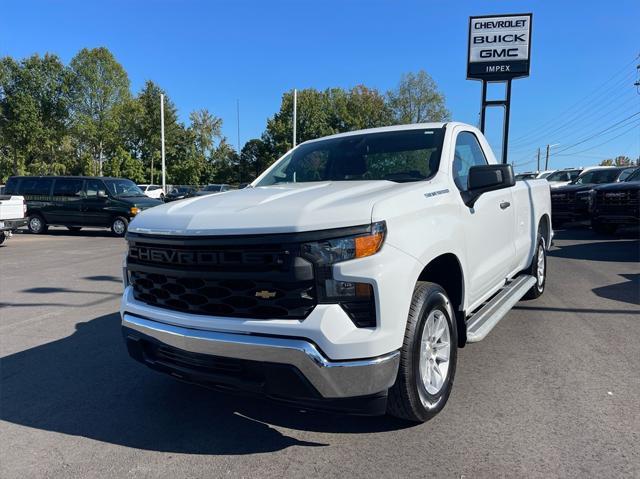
[6,176,162,236]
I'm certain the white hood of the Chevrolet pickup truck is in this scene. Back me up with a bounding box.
[129,181,401,235]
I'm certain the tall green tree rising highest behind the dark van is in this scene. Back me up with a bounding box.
[70,47,130,173]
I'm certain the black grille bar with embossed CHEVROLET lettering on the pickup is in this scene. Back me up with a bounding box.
[129,246,287,266]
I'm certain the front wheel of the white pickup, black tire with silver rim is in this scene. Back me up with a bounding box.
[387,282,458,422]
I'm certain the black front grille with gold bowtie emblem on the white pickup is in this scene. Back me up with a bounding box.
[127,238,317,319]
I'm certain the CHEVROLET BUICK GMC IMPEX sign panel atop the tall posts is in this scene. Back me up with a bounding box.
[467,13,532,81]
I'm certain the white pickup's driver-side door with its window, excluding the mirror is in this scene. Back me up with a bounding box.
[453,131,515,304]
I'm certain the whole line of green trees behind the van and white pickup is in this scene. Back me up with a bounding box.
[0,48,449,185]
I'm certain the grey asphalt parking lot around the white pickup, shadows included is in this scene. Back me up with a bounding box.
[0,228,640,478]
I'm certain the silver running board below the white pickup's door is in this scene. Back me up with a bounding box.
[467,274,536,343]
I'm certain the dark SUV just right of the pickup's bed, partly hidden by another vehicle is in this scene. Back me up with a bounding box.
[551,166,628,226]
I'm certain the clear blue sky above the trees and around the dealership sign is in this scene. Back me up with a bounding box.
[0,0,640,170]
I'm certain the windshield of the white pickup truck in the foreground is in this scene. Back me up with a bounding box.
[256,128,444,186]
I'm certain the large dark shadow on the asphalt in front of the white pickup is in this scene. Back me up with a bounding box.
[0,314,409,454]
